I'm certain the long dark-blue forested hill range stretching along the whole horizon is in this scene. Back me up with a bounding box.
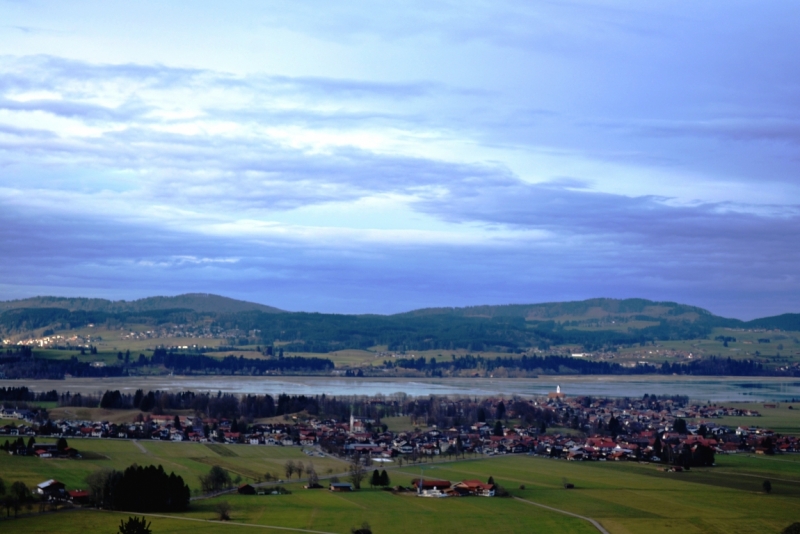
[0,293,800,353]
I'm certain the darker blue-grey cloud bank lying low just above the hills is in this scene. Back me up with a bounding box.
[0,194,800,317]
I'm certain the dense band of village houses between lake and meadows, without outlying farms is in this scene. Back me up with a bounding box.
[0,392,800,461]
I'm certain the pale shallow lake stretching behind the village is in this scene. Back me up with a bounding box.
[6,375,800,402]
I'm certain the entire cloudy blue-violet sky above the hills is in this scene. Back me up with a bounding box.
[0,0,800,319]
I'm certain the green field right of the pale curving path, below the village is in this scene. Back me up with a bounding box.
[396,456,800,534]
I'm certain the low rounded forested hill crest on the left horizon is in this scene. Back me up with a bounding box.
[0,293,283,313]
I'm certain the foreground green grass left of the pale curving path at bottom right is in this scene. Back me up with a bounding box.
[0,490,597,534]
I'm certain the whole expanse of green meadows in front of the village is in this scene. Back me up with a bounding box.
[0,440,800,534]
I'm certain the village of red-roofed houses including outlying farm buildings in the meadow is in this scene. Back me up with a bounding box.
[0,388,800,524]
